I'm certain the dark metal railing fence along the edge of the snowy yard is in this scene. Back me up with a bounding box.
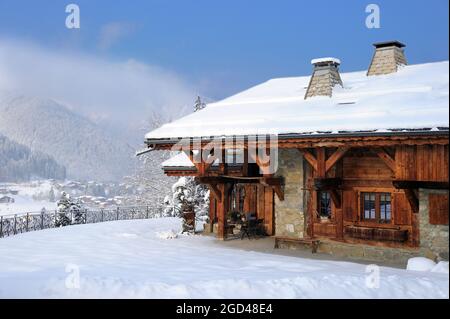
[0,205,165,238]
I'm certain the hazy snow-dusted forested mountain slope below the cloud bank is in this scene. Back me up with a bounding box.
[0,93,137,181]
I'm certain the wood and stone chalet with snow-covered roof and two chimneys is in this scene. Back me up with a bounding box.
[145,41,449,260]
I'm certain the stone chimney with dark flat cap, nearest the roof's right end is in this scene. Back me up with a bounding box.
[367,41,408,76]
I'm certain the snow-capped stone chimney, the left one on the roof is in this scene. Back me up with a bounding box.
[305,58,343,99]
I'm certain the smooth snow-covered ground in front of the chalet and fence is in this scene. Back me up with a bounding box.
[0,218,449,299]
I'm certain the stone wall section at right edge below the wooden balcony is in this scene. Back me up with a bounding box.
[419,189,449,260]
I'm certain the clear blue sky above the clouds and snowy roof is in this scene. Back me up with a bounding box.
[0,0,449,99]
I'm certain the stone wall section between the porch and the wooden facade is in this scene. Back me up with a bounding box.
[275,149,306,238]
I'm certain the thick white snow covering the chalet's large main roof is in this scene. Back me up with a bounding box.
[146,61,449,139]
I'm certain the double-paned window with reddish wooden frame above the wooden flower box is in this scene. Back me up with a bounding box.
[361,193,392,224]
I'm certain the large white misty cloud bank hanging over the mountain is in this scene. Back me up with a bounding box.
[0,39,195,139]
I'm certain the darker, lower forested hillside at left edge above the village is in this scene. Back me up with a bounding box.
[0,134,66,182]
